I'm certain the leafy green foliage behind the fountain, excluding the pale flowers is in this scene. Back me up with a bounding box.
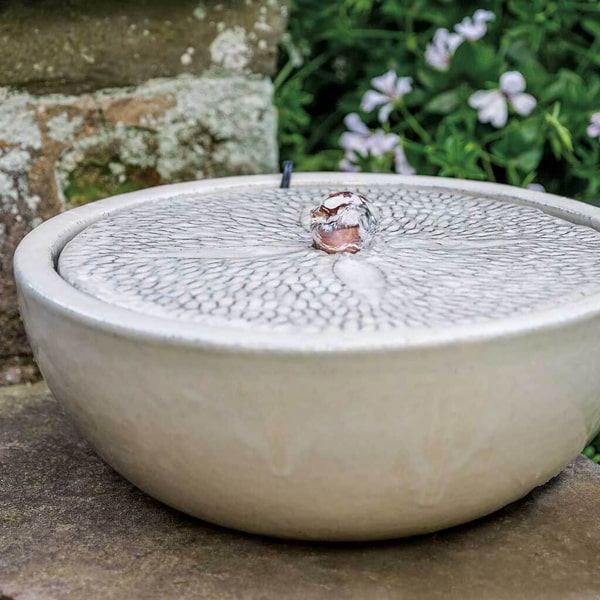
[275,0,600,202]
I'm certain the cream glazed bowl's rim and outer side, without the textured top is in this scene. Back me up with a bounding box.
[15,173,600,540]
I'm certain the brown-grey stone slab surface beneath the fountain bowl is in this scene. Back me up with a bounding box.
[0,384,600,600]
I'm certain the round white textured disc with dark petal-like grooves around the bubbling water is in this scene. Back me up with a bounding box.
[58,186,600,332]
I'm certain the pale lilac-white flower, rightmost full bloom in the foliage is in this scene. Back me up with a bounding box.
[469,71,537,128]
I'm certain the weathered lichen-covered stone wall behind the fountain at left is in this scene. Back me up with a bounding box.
[0,0,287,385]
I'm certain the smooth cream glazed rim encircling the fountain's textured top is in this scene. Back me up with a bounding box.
[14,172,600,353]
